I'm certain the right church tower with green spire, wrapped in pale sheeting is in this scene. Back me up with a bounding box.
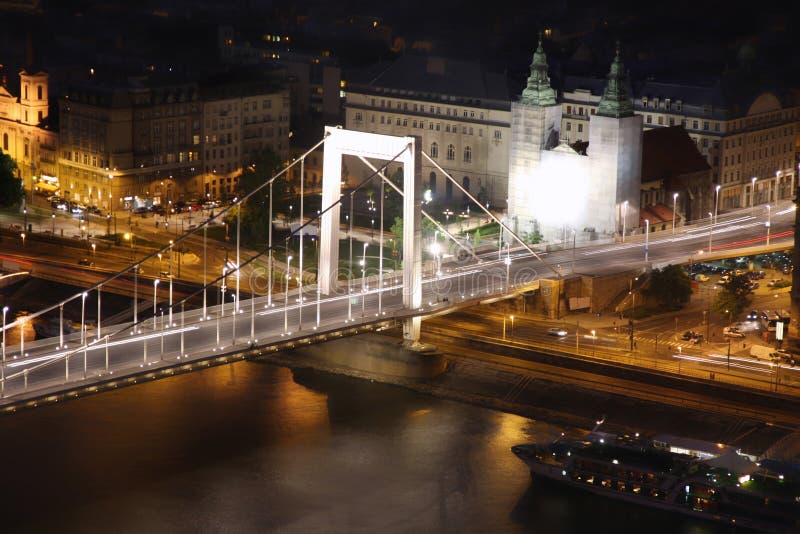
[587,43,643,239]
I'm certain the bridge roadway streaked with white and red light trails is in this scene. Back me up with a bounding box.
[0,204,794,405]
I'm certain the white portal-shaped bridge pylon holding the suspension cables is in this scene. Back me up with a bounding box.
[319,126,422,344]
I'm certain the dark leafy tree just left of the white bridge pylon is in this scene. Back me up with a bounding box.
[233,148,294,244]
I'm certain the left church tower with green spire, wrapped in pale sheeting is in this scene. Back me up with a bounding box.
[506,33,561,238]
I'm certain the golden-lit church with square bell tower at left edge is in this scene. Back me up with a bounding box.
[0,70,59,199]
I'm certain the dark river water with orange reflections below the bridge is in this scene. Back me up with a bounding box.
[0,362,730,534]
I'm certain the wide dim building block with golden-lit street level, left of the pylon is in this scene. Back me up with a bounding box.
[58,74,289,211]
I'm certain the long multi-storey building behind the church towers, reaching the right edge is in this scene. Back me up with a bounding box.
[561,76,800,216]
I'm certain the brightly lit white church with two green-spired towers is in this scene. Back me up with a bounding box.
[508,40,642,242]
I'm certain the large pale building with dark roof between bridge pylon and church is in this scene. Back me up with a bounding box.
[345,55,511,208]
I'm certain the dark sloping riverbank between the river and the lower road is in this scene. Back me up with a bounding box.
[259,332,800,459]
